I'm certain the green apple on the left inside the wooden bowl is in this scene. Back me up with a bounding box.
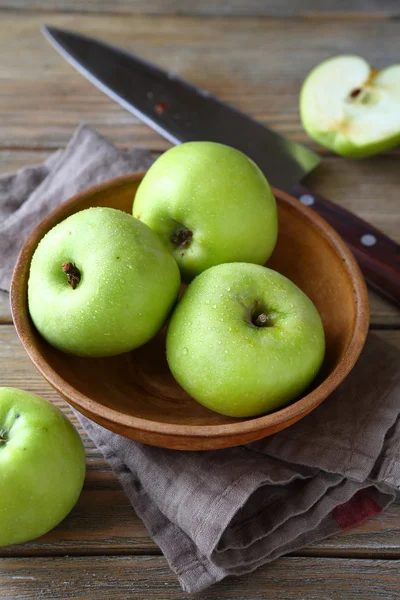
[28,208,180,356]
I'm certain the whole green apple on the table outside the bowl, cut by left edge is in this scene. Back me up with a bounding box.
[0,387,86,546]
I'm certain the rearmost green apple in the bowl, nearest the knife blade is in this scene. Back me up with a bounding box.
[133,142,278,280]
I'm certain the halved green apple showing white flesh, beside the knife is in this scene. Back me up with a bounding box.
[300,55,400,158]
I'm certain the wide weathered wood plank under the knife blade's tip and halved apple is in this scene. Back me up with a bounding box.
[0,13,400,149]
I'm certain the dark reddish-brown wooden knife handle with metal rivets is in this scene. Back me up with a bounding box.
[292,184,400,304]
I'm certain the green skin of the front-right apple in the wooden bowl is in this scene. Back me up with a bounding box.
[167,263,325,417]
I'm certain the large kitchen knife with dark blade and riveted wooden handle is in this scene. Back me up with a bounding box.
[42,26,400,303]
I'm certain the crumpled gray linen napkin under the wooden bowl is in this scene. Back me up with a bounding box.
[0,126,400,592]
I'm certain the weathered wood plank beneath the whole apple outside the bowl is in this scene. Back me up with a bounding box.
[0,325,400,556]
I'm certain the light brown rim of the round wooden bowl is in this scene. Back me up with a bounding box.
[10,171,369,439]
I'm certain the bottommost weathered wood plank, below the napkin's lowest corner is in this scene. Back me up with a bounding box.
[0,556,400,600]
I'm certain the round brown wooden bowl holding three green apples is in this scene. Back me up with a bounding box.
[11,173,369,450]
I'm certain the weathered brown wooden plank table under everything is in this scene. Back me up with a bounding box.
[0,0,400,600]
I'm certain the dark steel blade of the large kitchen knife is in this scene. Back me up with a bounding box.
[43,27,320,191]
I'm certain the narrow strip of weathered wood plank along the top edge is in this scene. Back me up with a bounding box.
[0,0,399,18]
